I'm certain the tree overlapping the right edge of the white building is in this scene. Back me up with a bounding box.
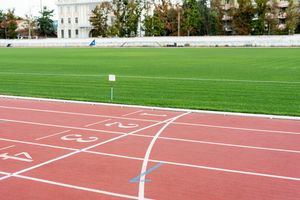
[90,2,112,37]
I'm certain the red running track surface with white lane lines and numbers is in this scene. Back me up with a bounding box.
[0,98,300,200]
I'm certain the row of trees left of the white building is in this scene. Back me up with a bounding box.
[0,7,55,39]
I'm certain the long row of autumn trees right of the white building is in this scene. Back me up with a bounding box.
[90,0,300,37]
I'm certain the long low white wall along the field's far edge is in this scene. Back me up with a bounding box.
[0,35,300,47]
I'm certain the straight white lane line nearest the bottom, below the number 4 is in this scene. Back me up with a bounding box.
[13,175,145,199]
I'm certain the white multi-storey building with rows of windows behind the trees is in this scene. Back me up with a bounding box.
[56,0,103,38]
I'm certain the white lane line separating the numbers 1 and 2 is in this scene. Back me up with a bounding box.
[0,106,157,122]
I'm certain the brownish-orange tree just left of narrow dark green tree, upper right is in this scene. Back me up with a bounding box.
[233,0,254,35]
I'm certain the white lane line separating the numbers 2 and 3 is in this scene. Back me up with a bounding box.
[2,119,127,135]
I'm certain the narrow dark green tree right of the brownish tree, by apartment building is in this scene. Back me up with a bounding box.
[253,0,269,35]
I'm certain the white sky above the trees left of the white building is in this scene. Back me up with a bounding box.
[0,0,57,19]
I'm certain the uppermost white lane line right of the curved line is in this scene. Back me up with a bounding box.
[173,122,300,135]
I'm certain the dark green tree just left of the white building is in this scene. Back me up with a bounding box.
[37,6,54,37]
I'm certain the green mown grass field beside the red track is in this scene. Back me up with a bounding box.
[0,48,300,116]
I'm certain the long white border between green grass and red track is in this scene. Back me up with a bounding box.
[0,95,300,121]
